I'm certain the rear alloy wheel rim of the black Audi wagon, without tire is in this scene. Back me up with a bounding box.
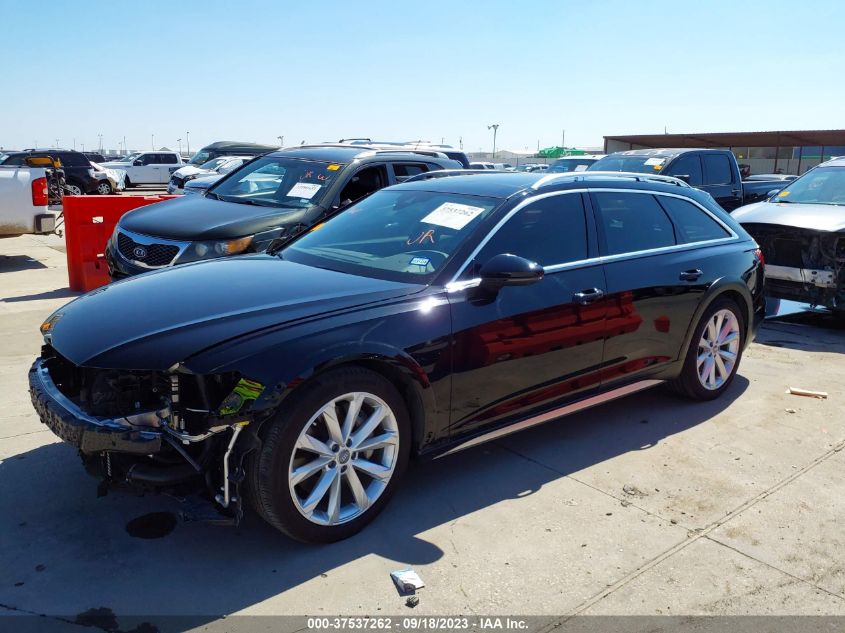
[696,309,740,391]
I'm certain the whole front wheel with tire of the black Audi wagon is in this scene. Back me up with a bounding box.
[247,367,411,543]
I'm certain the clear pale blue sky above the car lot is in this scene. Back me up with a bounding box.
[0,0,845,151]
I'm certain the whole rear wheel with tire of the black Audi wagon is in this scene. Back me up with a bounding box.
[670,297,745,400]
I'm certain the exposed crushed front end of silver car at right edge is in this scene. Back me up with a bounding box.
[743,223,845,310]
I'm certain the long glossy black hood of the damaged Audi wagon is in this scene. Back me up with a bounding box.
[50,255,424,371]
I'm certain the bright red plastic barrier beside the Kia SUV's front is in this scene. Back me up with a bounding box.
[62,196,176,292]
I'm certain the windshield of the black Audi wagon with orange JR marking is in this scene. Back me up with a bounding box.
[281,190,500,283]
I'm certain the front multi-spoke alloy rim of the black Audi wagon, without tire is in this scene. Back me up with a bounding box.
[288,392,399,526]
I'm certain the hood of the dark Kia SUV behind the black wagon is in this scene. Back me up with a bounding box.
[118,196,313,241]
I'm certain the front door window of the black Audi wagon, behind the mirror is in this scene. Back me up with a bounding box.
[477,193,588,266]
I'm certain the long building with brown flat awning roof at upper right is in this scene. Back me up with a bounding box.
[604,130,845,175]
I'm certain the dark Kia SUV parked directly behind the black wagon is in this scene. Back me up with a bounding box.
[106,145,461,279]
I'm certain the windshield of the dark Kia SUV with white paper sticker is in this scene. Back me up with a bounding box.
[209,156,343,209]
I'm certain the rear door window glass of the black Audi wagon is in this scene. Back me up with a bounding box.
[592,191,675,255]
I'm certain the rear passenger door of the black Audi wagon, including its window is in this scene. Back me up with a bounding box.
[590,189,731,385]
